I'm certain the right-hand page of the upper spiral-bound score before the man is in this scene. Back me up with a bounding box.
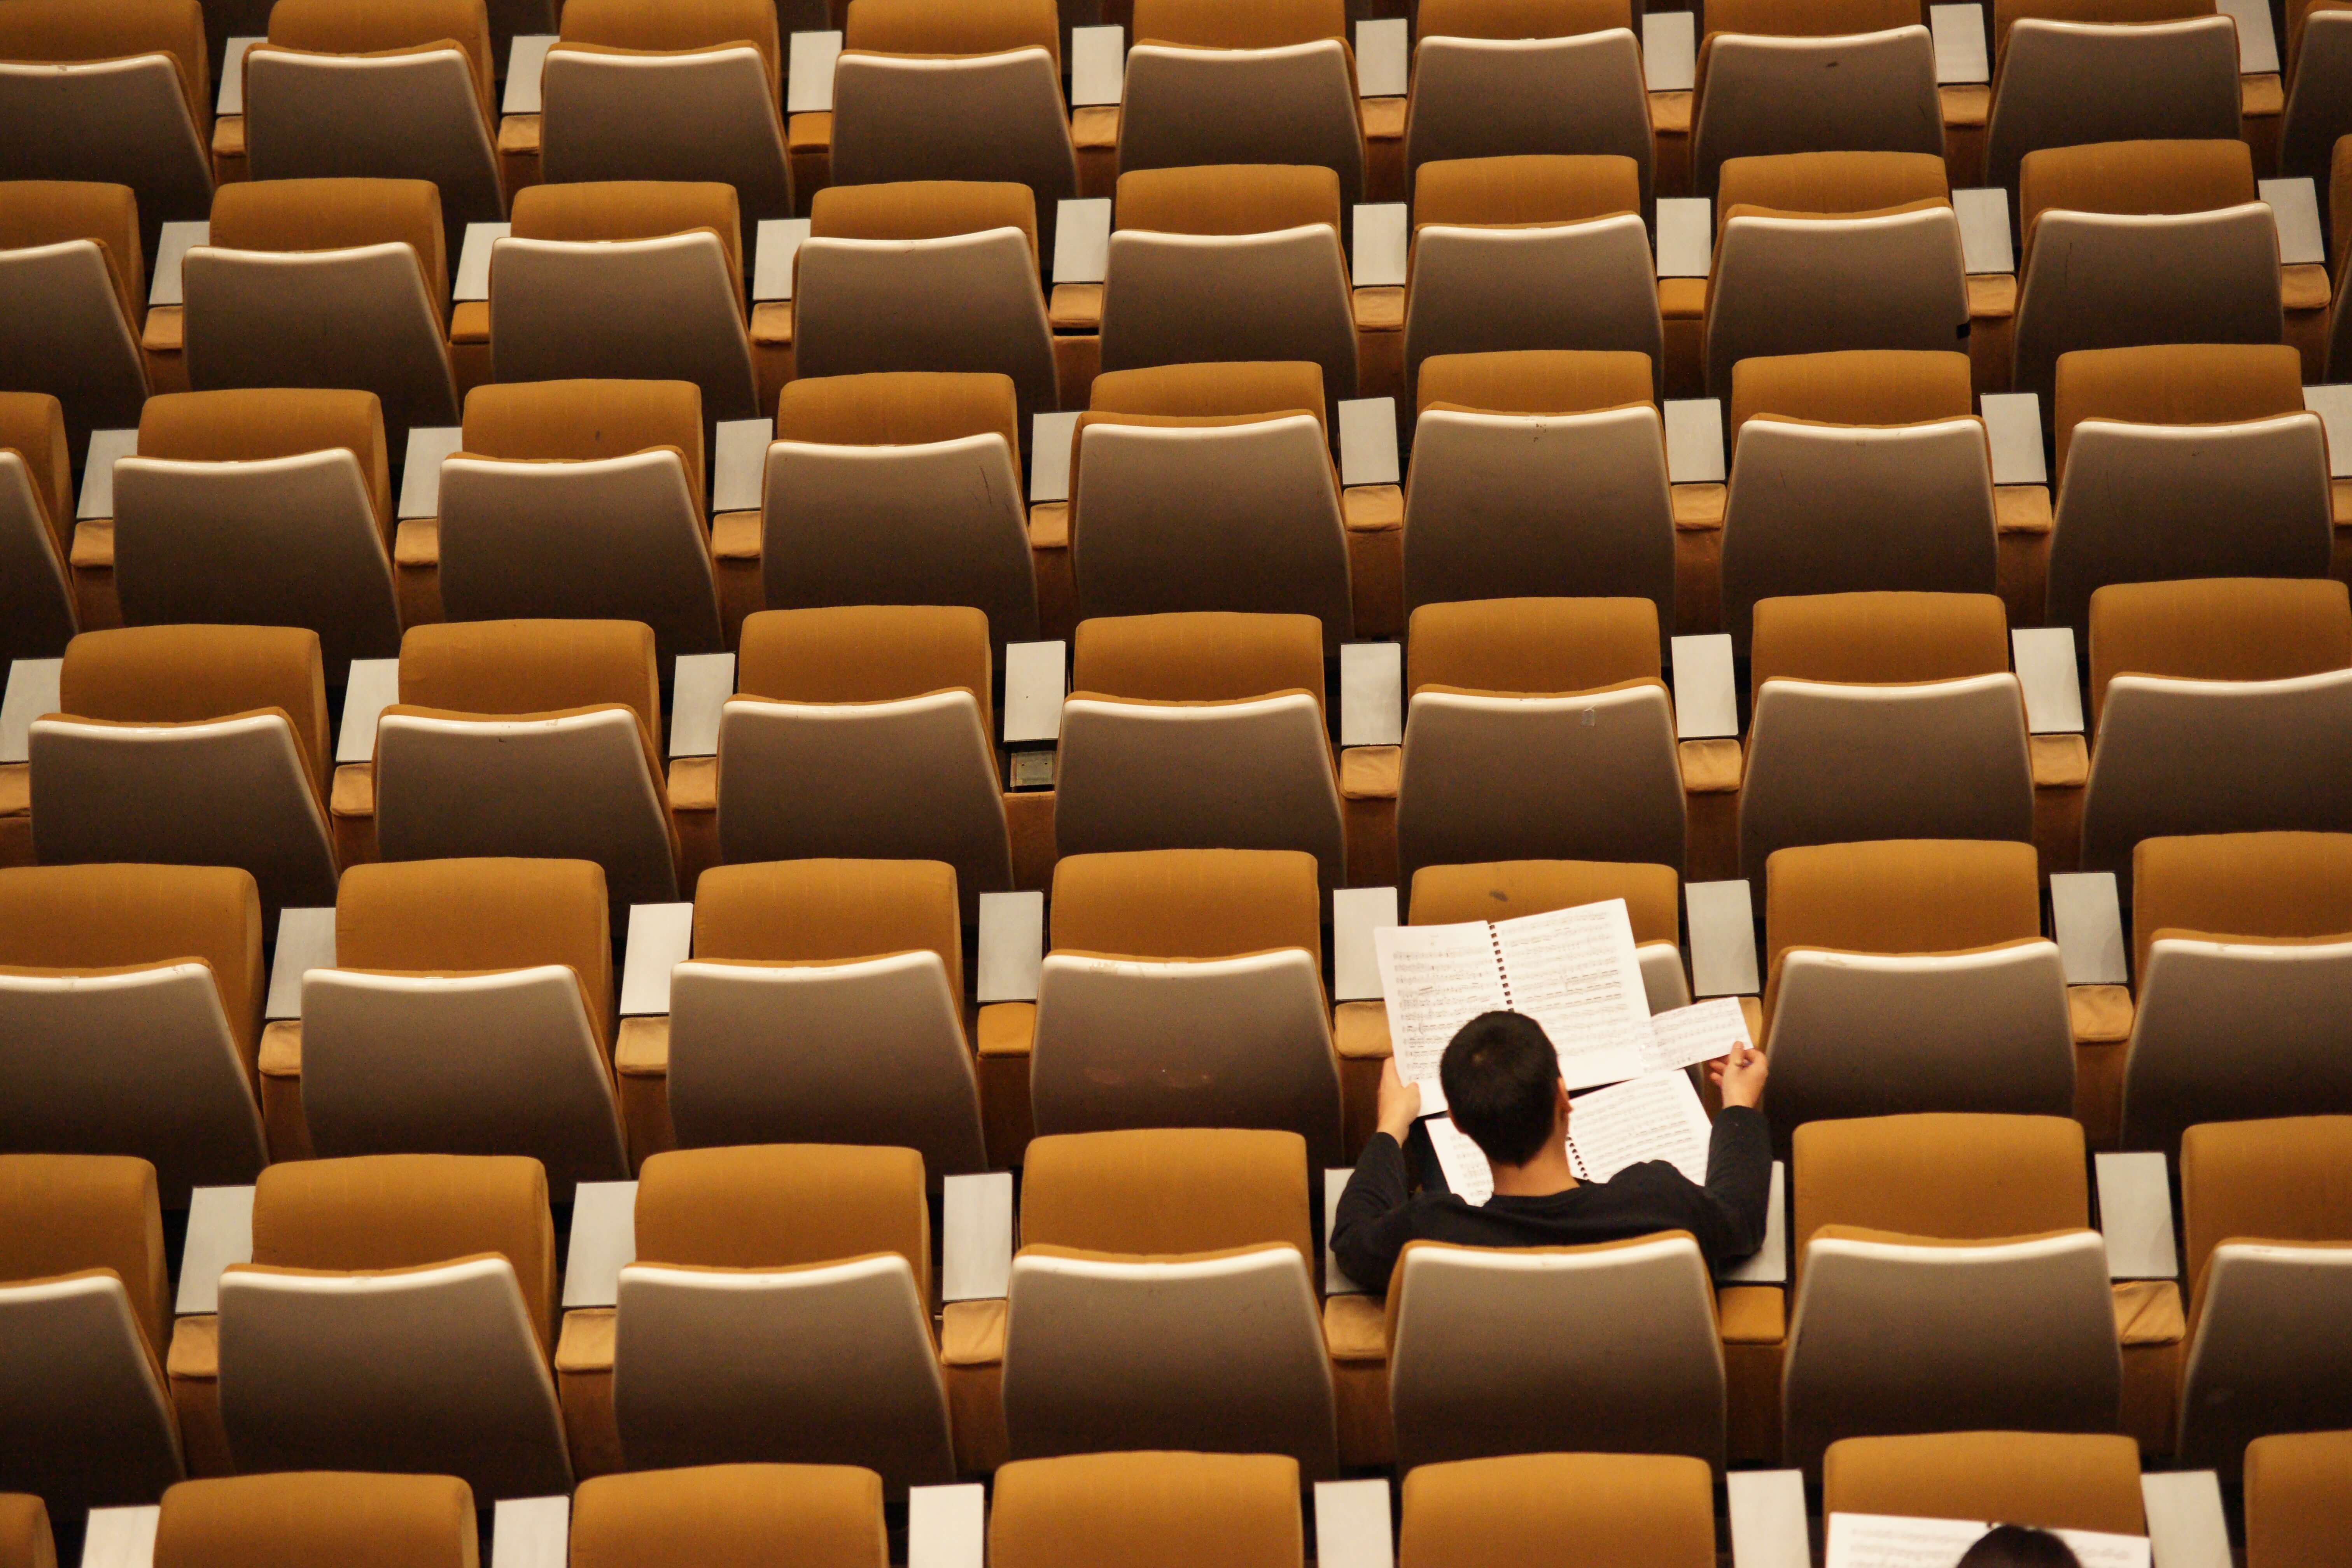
[1493,898,1651,1088]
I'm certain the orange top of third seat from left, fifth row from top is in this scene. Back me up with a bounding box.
[694,860,964,997]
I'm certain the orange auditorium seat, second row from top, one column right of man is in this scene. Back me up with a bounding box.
[1705,153,1969,397]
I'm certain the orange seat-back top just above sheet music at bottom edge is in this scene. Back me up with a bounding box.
[1820,1432,2147,1535]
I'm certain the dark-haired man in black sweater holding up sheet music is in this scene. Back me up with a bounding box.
[1331,1013,1771,1291]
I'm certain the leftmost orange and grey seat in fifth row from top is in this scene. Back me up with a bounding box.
[0,865,266,1208]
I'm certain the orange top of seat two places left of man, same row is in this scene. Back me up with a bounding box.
[637,1143,931,1300]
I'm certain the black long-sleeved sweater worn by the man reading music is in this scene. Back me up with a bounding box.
[1331,1105,1771,1293]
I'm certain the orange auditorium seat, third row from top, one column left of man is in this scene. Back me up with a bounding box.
[1070,360,1355,656]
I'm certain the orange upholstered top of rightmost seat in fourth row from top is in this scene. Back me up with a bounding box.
[2091,578,2352,729]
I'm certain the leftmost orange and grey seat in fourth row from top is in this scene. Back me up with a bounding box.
[31,625,334,919]
